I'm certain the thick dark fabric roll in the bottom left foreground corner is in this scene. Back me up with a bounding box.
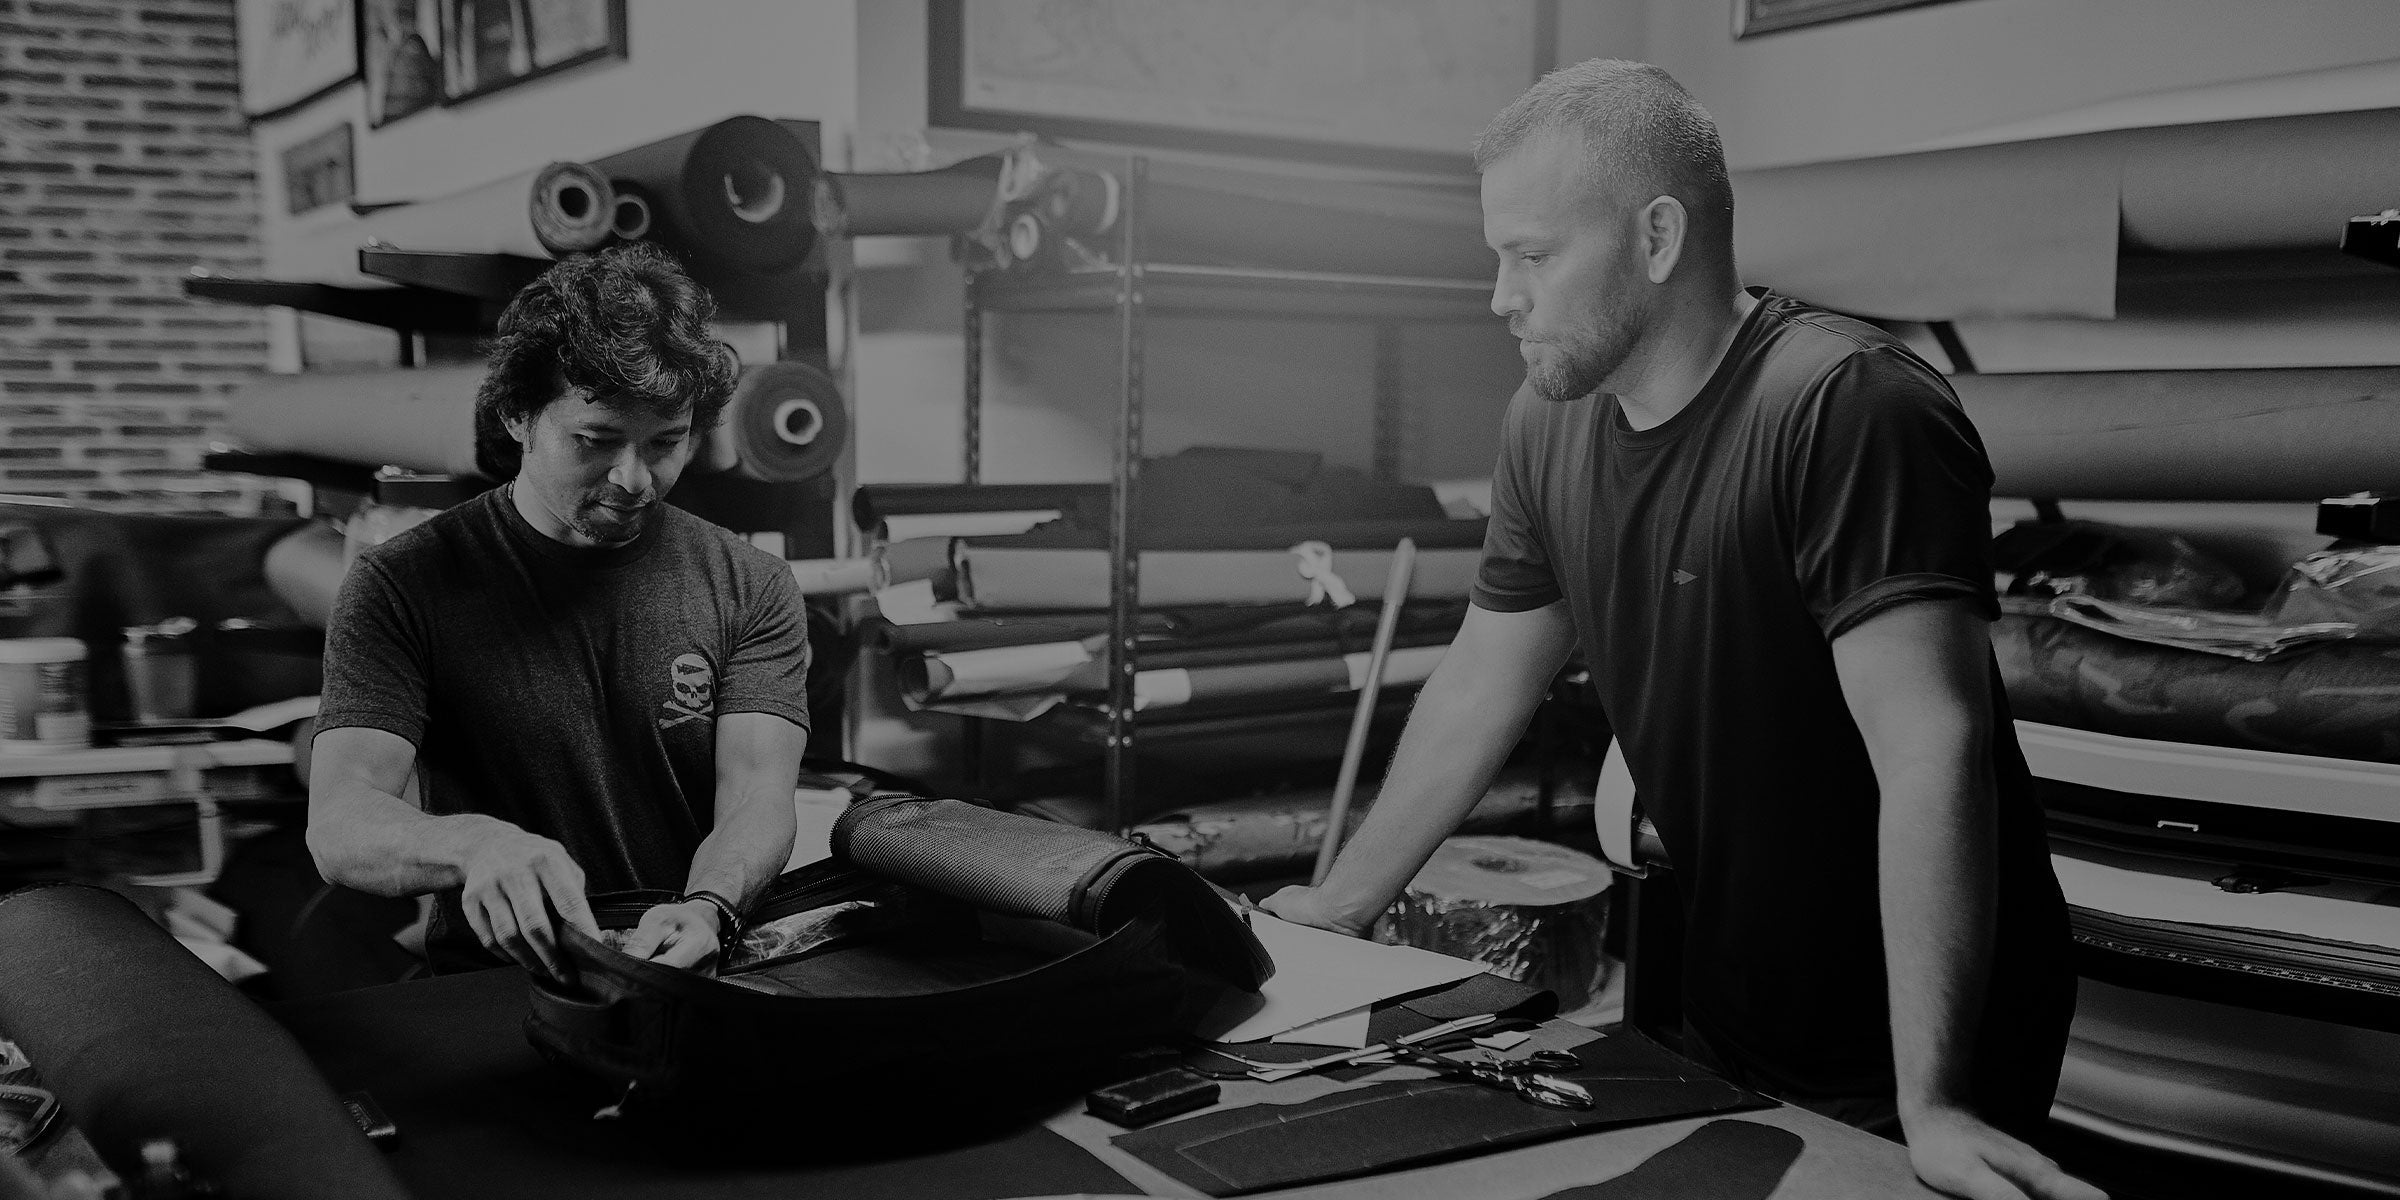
[0,886,408,1200]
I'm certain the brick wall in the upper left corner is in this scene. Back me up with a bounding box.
[0,0,266,511]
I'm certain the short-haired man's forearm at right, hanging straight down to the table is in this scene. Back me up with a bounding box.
[1877,758,1999,1121]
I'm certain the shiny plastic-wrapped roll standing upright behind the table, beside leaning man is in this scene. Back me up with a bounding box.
[1375,838,1615,1013]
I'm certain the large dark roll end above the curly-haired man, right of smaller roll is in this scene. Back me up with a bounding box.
[590,115,816,276]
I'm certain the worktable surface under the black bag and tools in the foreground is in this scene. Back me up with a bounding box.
[248,970,1934,1200]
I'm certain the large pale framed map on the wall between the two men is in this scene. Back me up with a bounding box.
[926,0,1558,170]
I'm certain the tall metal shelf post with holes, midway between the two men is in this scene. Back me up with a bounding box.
[1106,156,1150,830]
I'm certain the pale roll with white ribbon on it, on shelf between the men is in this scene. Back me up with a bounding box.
[955,542,1483,610]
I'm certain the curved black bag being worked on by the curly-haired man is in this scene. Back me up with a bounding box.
[526,794,1274,1121]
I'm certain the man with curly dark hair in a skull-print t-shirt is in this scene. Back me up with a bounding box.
[307,245,809,977]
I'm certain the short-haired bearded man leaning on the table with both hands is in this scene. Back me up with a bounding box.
[1267,60,2098,1200]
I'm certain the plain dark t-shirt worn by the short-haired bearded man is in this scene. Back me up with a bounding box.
[1474,288,2066,1092]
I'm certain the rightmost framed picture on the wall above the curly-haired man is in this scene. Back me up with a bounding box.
[434,0,626,101]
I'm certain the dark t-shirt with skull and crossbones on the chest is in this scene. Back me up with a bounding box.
[317,490,809,950]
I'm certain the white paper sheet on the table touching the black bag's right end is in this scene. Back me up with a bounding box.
[1200,912,1483,1042]
